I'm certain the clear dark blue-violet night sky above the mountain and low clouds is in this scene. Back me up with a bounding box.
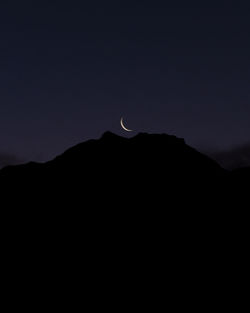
[0,0,250,160]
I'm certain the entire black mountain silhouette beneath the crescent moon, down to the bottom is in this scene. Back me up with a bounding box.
[0,132,249,311]
